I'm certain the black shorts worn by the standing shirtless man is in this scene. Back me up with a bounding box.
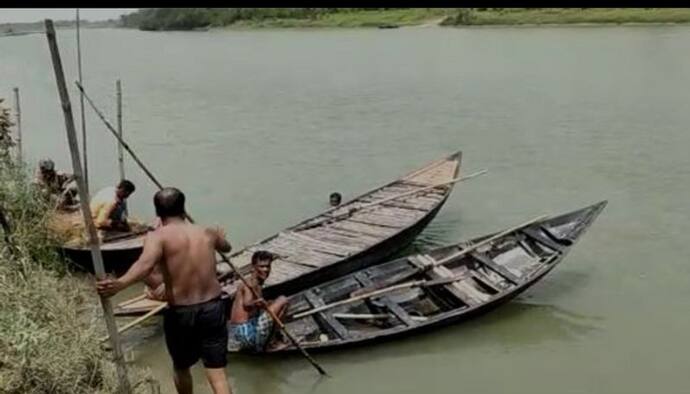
[163,296,228,369]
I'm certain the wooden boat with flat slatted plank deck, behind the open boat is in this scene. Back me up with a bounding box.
[115,152,462,315]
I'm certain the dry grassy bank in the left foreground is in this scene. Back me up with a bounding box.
[0,103,156,394]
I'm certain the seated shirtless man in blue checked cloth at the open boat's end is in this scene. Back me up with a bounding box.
[230,250,288,352]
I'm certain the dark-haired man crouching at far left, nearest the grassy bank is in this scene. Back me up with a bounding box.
[33,159,79,210]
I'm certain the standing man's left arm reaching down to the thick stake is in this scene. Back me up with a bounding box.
[96,233,163,297]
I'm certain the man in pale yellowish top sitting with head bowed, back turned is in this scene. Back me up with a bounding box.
[91,179,135,231]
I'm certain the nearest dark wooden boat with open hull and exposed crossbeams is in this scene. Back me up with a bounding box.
[228,201,607,353]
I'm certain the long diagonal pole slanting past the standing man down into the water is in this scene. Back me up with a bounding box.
[75,82,328,375]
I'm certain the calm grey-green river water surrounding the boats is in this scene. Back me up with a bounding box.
[0,26,690,394]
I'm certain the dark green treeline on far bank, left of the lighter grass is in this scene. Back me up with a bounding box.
[120,8,412,30]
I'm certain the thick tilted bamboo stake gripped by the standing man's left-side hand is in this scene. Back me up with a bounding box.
[45,19,132,394]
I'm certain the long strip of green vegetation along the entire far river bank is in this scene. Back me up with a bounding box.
[120,8,690,30]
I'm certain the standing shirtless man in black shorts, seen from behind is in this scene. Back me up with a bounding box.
[96,187,231,394]
